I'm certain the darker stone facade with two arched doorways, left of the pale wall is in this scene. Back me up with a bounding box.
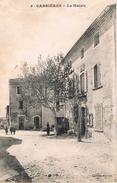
[9,78,42,130]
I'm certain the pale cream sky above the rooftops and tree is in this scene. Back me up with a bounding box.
[0,0,115,117]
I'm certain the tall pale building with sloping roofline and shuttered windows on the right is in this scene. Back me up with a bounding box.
[64,5,116,139]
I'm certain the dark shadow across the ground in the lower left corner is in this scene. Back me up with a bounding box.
[0,137,32,183]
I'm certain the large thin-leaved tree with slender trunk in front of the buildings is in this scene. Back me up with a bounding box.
[22,54,72,134]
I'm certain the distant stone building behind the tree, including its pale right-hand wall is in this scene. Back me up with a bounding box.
[9,78,54,130]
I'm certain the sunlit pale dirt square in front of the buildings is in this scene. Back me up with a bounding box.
[0,130,116,183]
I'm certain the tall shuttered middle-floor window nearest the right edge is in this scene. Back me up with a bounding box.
[94,64,101,89]
